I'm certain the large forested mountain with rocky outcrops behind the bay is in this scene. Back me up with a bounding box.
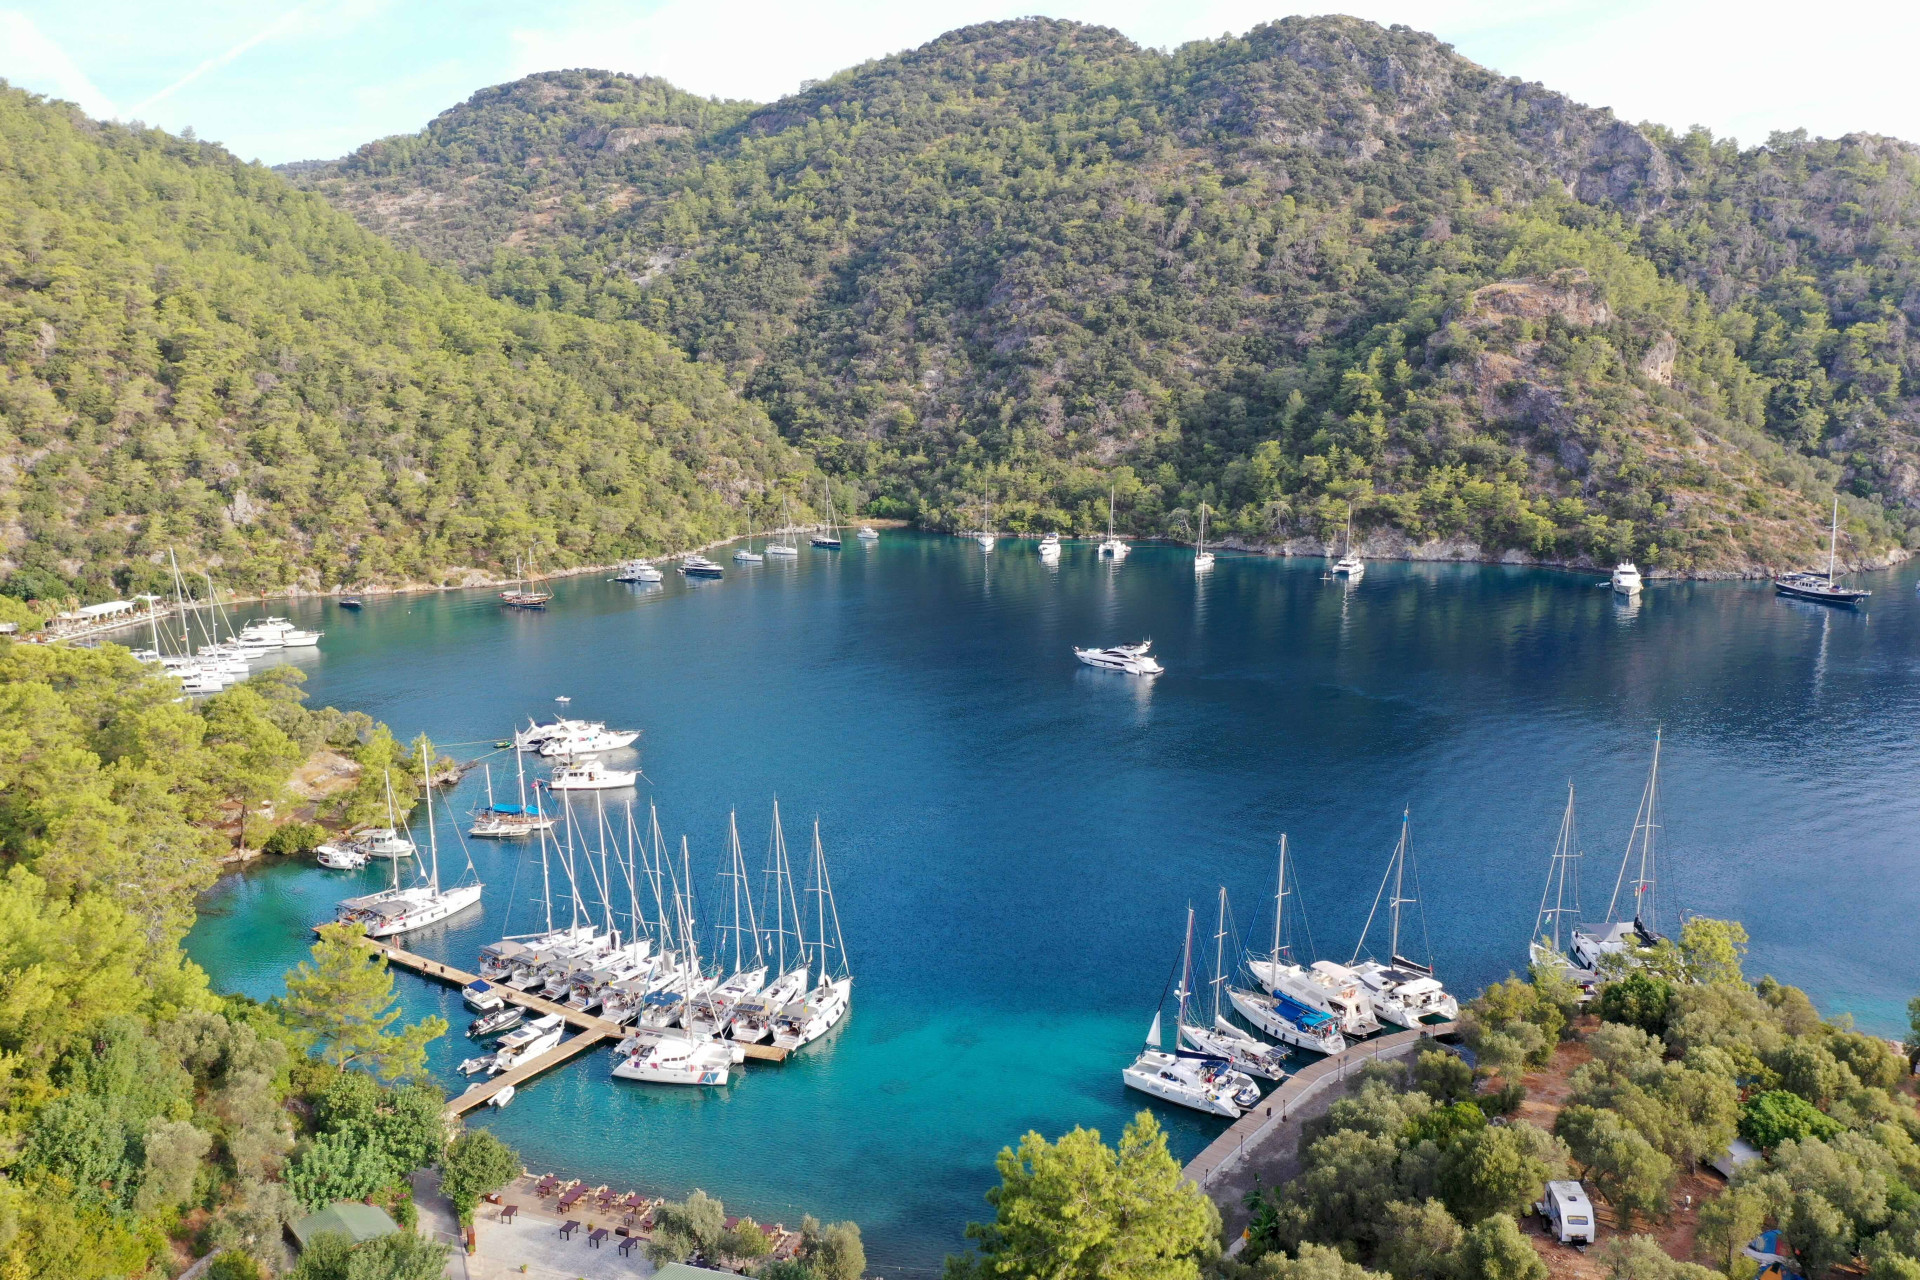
[290,17,1920,572]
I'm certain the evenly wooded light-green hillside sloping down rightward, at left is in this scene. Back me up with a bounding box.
[0,86,810,595]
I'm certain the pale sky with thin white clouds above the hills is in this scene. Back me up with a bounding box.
[0,0,1920,163]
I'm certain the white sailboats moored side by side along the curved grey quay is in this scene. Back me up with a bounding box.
[1121,816,1459,1117]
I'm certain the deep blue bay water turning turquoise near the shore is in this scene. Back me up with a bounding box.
[188,532,1920,1274]
